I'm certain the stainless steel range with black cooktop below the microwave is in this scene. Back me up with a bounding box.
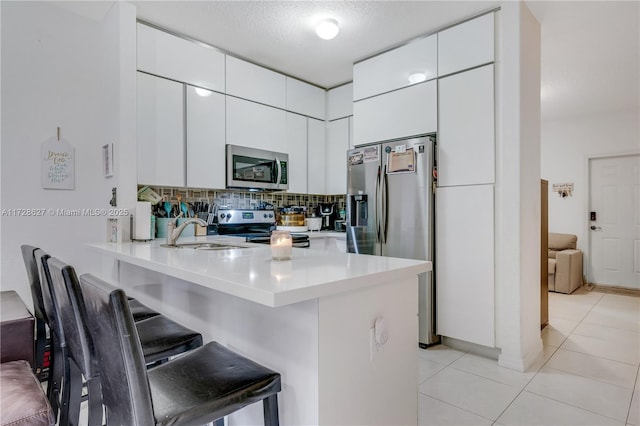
[213,210,310,248]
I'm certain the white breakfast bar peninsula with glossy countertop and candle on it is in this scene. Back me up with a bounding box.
[90,237,431,425]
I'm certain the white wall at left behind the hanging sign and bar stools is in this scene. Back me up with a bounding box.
[0,1,135,304]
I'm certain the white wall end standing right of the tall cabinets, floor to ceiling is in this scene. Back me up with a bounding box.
[495,2,542,371]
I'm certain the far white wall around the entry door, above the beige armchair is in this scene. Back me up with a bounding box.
[541,109,640,251]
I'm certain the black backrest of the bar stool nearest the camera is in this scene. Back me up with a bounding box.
[80,274,156,426]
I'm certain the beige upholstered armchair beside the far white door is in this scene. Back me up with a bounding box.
[548,232,582,294]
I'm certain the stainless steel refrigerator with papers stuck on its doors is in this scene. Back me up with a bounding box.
[346,135,439,347]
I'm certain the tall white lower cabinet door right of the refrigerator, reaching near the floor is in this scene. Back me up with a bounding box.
[435,185,495,348]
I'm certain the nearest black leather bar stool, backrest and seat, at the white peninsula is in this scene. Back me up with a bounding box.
[80,274,281,426]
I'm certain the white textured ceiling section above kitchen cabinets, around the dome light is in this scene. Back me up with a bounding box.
[133,1,498,88]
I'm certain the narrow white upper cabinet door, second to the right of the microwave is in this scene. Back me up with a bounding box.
[307,118,327,194]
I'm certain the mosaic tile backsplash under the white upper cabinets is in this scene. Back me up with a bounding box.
[144,185,346,213]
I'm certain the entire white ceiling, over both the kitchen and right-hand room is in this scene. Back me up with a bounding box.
[48,0,640,119]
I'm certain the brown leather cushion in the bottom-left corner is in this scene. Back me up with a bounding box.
[0,360,55,426]
